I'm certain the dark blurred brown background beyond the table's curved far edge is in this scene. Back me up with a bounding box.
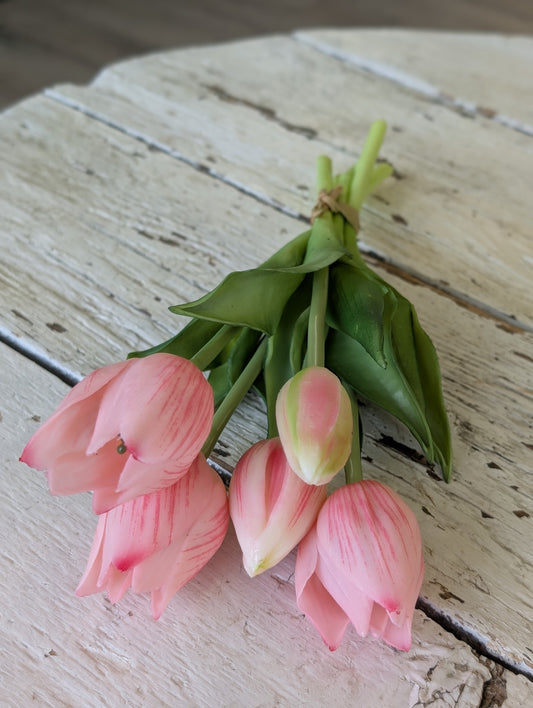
[0,0,533,109]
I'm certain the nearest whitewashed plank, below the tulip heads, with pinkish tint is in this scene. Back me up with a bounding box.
[0,345,533,708]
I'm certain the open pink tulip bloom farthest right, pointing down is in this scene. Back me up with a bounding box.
[295,480,424,651]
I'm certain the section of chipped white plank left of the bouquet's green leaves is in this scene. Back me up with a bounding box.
[0,97,304,374]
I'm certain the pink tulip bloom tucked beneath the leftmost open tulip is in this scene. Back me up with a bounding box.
[76,454,229,619]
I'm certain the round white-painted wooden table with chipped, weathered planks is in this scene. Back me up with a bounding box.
[0,31,533,708]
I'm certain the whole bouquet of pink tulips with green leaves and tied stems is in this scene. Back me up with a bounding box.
[21,121,451,650]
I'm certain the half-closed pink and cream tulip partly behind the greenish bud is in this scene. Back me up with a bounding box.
[229,438,327,577]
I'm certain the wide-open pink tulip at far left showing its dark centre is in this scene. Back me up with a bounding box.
[20,354,213,514]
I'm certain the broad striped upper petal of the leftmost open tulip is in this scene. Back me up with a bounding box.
[89,354,213,465]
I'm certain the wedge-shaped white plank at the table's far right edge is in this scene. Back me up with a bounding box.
[297,28,533,129]
